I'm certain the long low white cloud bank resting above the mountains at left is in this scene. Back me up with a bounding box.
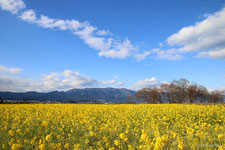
[0,67,124,92]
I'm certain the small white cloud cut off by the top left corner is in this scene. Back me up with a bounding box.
[0,0,26,14]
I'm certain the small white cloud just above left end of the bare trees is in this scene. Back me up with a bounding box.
[133,77,161,88]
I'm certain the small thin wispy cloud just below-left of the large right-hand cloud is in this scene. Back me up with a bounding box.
[151,48,183,60]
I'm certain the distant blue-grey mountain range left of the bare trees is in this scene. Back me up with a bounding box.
[0,88,135,103]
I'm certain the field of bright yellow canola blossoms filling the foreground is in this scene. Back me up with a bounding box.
[0,104,225,150]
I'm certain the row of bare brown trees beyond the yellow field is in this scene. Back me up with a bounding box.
[135,78,224,104]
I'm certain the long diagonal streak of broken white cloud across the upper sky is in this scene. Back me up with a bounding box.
[16,6,150,61]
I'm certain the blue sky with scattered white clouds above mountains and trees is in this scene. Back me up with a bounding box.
[0,0,225,92]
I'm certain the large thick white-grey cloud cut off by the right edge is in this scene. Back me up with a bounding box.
[167,8,225,59]
